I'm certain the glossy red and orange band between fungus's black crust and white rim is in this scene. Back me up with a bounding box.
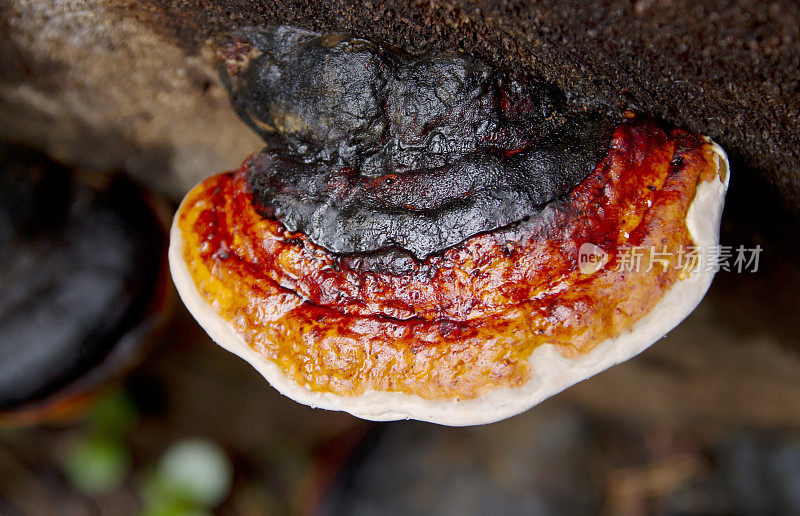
[177,119,716,399]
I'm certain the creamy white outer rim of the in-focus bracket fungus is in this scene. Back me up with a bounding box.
[169,131,729,426]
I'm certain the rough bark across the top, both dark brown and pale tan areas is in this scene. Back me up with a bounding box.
[0,0,800,209]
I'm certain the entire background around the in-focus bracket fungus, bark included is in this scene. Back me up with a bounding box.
[0,0,800,516]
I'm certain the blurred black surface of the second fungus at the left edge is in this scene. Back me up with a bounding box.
[0,146,165,411]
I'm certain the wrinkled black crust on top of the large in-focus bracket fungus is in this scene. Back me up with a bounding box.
[232,27,615,259]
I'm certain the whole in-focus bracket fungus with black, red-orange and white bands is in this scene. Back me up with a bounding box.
[169,27,728,425]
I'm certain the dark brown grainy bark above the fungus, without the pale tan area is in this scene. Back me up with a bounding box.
[145,0,800,211]
